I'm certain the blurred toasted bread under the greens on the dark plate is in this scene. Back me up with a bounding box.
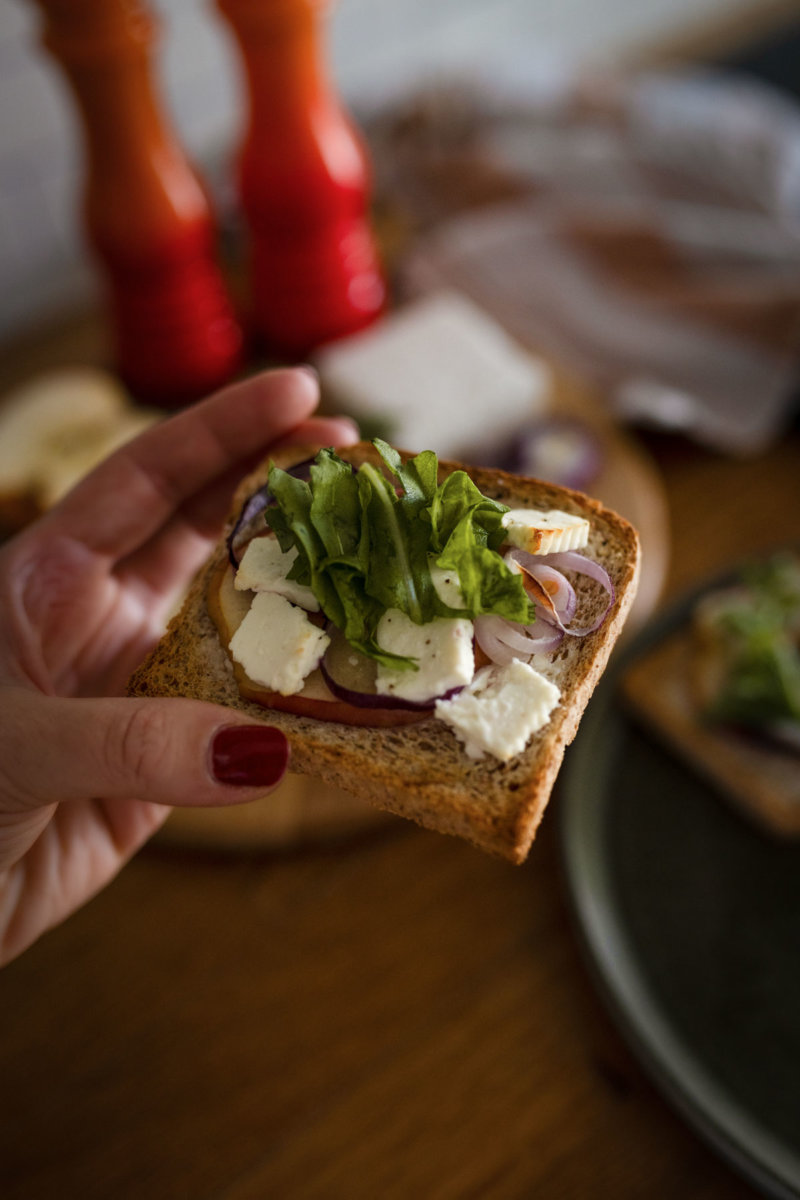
[622,624,800,838]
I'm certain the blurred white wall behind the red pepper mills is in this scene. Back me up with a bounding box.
[0,0,777,337]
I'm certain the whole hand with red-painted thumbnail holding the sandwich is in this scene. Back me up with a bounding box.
[0,370,357,962]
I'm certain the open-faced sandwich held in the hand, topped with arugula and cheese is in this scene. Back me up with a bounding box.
[130,442,639,862]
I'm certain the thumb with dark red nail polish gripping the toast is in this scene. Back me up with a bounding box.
[0,691,289,810]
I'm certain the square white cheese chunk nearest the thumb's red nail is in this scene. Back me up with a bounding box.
[230,592,330,696]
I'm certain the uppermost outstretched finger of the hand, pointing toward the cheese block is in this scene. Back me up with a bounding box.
[44,370,319,562]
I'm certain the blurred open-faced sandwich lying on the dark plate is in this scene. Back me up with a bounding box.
[622,552,800,836]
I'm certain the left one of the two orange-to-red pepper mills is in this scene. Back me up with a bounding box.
[36,0,242,407]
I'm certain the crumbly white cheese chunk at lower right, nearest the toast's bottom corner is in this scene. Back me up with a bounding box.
[435,659,561,762]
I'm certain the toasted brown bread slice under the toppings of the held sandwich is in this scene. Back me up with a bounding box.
[128,443,639,863]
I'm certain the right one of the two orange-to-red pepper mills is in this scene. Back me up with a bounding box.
[217,0,385,358]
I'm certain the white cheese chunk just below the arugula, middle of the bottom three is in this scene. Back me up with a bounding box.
[375,608,475,703]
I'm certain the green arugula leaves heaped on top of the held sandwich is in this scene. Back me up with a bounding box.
[266,439,535,668]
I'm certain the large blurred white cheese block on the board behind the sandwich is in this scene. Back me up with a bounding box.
[314,290,552,458]
